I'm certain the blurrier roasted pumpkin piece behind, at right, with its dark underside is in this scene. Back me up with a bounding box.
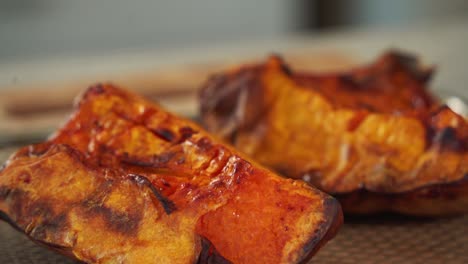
[200,52,468,215]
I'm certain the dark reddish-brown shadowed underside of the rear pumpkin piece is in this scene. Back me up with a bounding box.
[332,173,468,217]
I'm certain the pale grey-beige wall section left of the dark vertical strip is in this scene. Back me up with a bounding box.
[0,0,293,63]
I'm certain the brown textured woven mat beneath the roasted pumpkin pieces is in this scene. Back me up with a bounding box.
[0,149,468,264]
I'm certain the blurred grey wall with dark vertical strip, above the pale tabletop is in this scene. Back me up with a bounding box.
[0,0,468,63]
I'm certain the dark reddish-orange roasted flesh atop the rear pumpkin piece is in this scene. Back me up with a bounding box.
[292,52,438,114]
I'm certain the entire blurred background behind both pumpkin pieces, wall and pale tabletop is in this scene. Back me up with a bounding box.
[0,0,468,145]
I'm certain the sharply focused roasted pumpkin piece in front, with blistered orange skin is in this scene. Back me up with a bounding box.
[0,85,342,263]
